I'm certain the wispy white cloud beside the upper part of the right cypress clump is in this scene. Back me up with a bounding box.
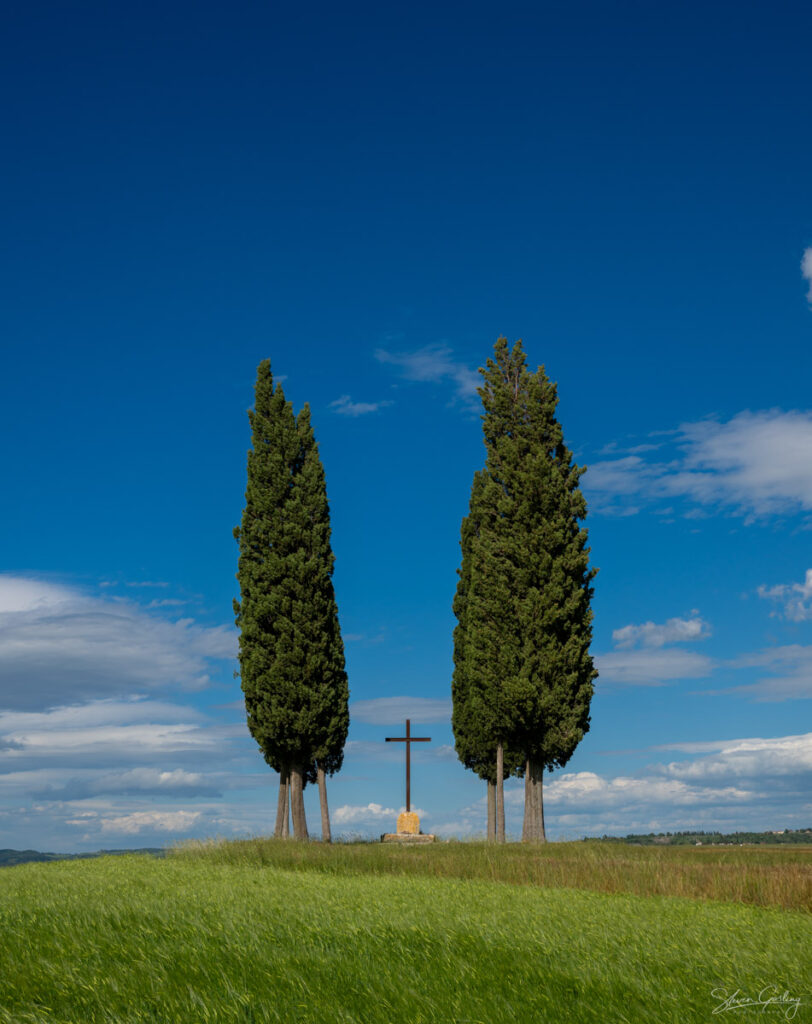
[584,409,812,517]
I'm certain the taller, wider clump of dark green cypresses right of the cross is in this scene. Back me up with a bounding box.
[452,338,597,842]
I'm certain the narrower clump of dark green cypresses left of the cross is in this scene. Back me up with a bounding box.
[234,359,349,842]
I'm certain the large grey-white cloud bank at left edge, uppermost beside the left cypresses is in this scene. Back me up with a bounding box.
[0,575,237,710]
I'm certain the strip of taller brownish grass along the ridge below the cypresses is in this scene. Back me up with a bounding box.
[170,839,812,911]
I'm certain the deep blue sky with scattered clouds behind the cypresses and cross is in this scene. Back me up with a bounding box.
[0,2,812,851]
